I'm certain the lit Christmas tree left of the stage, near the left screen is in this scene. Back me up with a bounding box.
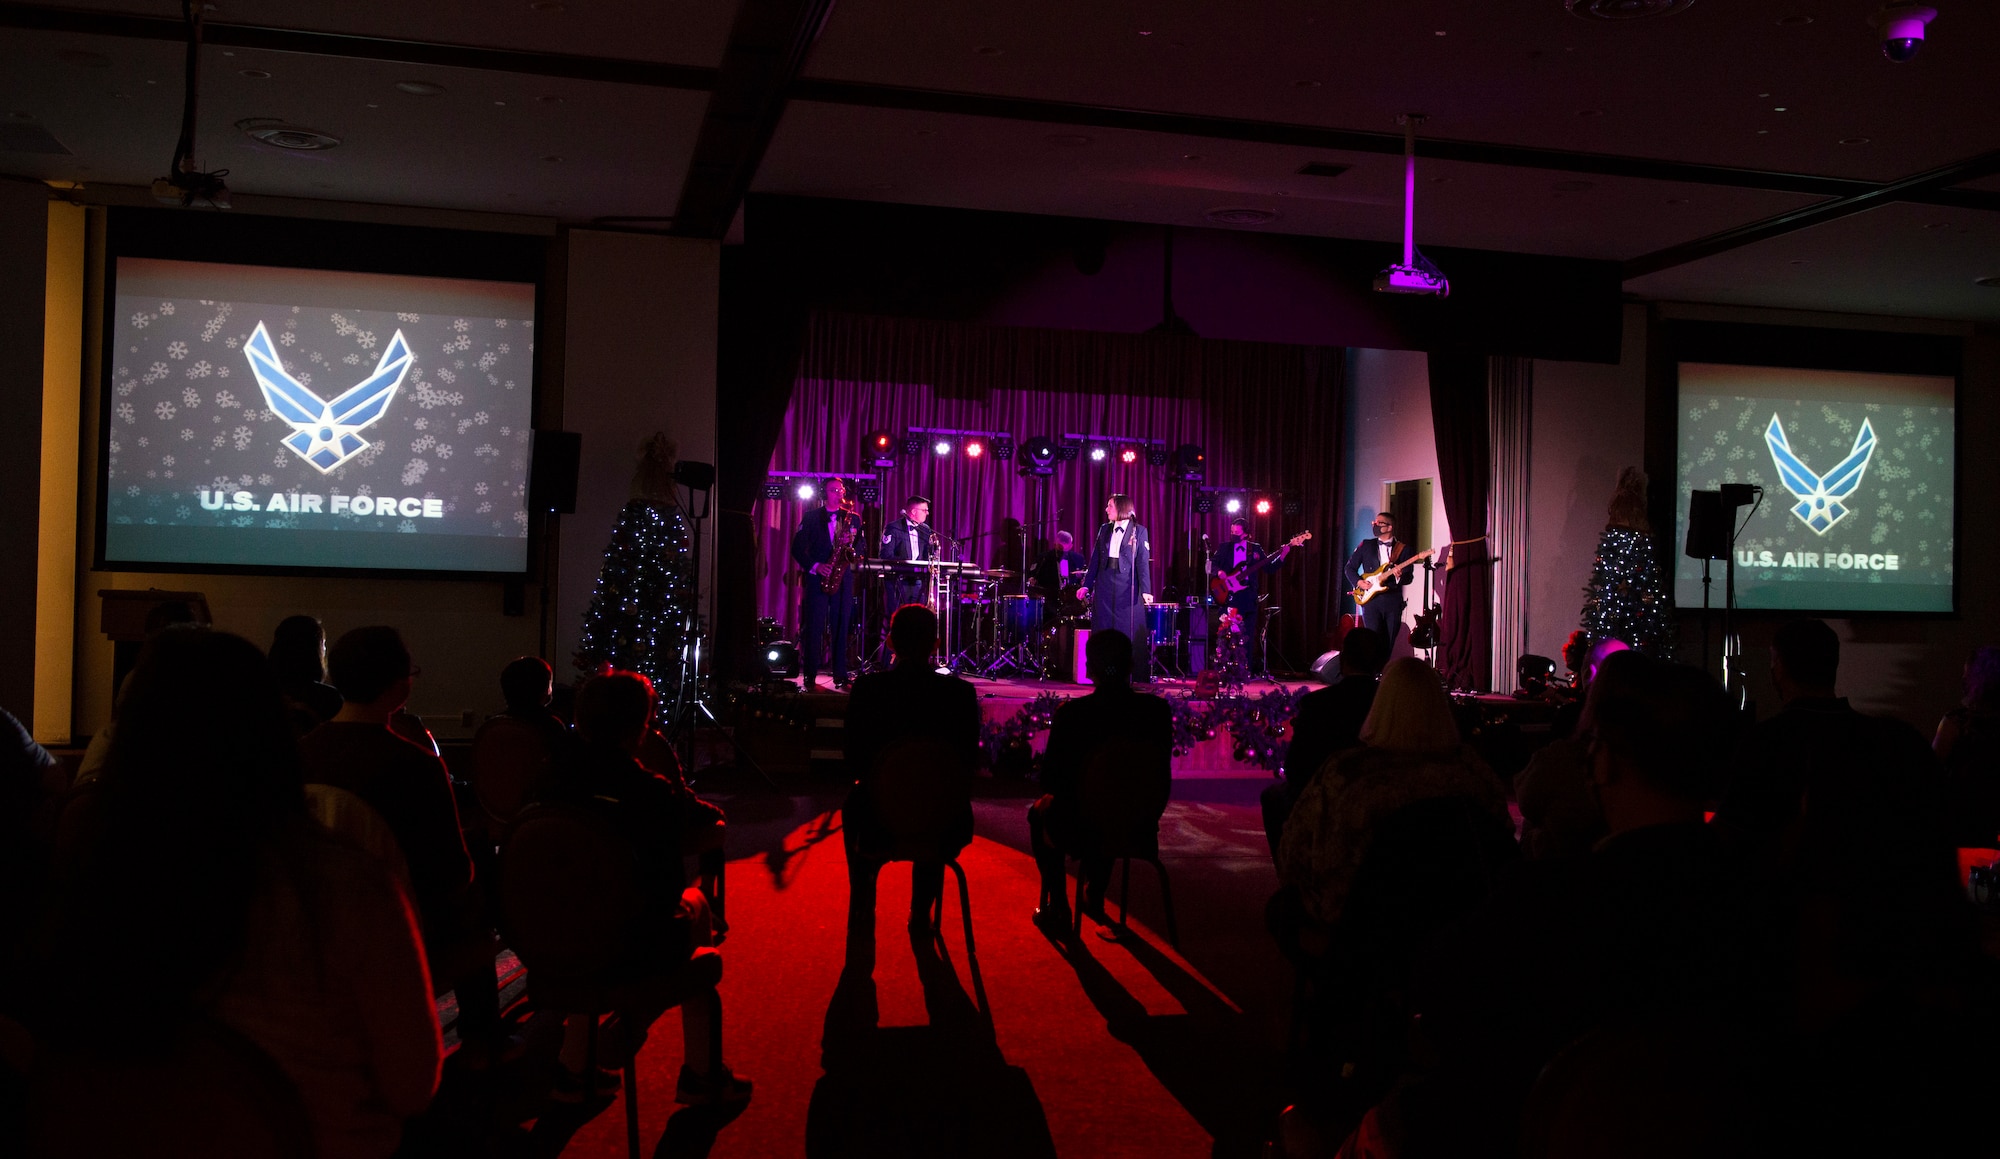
[574,434,696,691]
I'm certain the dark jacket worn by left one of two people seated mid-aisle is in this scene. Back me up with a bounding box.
[842,663,980,849]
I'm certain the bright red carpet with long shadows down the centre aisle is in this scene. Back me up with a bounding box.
[540,797,1268,1159]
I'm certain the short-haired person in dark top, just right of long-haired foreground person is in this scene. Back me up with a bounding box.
[298,627,508,1061]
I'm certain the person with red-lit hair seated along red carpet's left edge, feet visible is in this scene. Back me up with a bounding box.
[536,671,750,1103]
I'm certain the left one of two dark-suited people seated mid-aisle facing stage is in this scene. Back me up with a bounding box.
[842,603,980,947]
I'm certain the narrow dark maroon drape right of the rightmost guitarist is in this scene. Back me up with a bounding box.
[1430,352,1494,691]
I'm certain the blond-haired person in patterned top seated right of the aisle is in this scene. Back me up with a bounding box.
[1278,657,1506,925]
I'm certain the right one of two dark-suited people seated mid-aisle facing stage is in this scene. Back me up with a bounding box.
[1028,629,1174,935]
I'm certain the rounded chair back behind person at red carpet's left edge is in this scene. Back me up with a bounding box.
[500,803,646,985]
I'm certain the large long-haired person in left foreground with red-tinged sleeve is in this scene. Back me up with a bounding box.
[38,629,442,1159]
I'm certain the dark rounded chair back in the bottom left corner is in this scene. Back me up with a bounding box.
[28,1017,314,1159]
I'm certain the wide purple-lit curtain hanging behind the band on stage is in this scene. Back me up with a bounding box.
[752,314,1344,665]
